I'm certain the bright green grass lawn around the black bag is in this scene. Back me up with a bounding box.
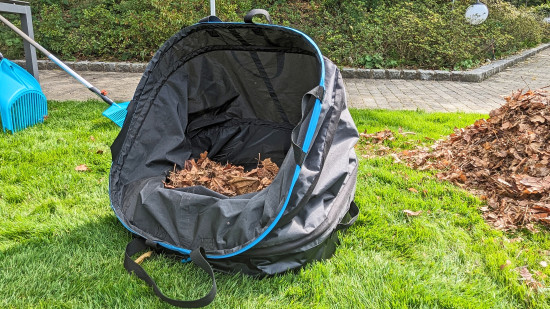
[0,101,550,308]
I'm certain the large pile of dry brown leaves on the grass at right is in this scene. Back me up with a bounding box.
[399,90,550,231]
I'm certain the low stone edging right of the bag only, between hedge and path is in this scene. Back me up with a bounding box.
[340,43,550,83]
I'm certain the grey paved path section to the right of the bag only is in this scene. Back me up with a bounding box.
[344,49,550,113]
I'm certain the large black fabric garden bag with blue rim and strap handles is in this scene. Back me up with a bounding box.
[110,10,359,307]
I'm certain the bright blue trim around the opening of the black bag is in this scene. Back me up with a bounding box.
[109,23,325,263]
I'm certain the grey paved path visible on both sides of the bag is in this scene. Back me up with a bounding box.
[40,48,550,113]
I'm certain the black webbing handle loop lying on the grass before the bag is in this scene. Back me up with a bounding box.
[124,238,216,308]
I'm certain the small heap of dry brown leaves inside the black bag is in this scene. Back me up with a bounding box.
[164,151,279,196]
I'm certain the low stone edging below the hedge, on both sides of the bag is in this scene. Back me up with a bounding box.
[14,43,550,83]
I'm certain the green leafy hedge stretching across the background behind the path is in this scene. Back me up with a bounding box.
[0,0,550,69]
